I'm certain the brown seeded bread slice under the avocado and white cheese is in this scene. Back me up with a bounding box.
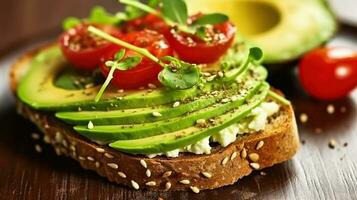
[10,46,299,193]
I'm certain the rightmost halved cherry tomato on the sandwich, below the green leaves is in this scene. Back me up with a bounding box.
[165,15,236,64]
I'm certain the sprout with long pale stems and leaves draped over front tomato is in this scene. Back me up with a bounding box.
[88,26,200,101]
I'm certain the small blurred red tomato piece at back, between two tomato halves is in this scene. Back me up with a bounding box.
[123,14,169,34]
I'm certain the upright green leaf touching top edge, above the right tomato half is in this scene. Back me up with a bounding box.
[161,0,188,25]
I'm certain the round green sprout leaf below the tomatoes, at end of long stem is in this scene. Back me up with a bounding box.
[159,56,200,90]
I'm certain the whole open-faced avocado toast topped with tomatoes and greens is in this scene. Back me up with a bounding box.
[11,0,299,193]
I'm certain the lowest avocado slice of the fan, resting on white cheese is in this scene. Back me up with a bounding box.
[109,83,269,154]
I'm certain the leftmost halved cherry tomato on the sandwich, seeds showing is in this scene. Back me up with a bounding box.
[59,24,122,70]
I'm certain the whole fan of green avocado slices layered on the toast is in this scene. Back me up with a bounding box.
[18,43,269,154]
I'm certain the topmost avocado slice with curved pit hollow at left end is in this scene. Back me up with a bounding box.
[17,46,206,111]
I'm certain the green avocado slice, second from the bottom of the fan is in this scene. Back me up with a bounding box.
[74,72,262,143]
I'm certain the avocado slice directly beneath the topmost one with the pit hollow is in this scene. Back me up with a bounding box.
[56,64,267,125]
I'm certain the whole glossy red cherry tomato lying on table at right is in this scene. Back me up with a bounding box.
[299,48,357,100]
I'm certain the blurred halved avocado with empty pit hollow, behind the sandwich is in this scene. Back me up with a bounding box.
[187,0,337,64]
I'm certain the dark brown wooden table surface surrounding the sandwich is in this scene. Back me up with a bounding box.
[0,0,357,200]
